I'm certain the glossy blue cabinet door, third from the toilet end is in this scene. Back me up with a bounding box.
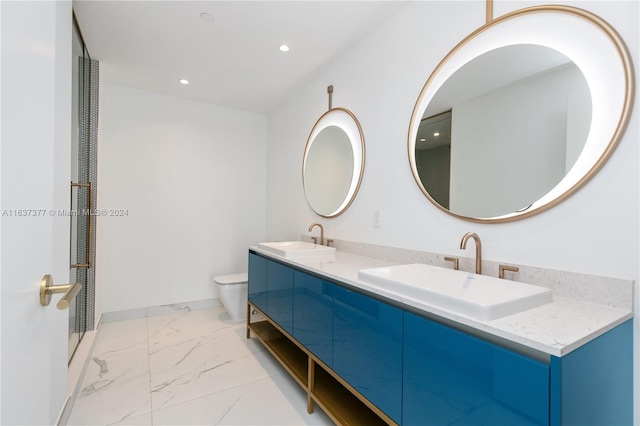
[293,271,335,367]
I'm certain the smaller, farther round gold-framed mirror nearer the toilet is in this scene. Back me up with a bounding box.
[302,108,364,217]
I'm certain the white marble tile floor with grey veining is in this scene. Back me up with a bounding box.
[67,307,333,426]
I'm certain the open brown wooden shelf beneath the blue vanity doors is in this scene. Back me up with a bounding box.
[247,302,396,426]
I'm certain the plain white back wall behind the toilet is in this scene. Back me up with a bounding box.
[97,84,268,312]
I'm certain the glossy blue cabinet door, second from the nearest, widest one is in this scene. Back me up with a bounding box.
[333,286,402,423]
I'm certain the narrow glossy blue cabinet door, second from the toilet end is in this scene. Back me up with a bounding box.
[265,261,293,334]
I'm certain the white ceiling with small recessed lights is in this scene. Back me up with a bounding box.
[73,0,408,113]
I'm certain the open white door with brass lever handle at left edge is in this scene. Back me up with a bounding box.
[0,0,72,425]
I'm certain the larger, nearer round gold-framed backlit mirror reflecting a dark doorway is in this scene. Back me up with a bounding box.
[408,6,633,222]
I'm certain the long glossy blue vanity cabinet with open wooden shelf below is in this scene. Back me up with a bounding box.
[248,252,633,426]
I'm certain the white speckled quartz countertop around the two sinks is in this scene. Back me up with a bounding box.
[251,247,633,357]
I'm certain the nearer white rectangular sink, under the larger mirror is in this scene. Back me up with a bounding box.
[358,263,553,321]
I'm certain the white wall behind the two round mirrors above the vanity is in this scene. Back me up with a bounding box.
[267,0,640,423]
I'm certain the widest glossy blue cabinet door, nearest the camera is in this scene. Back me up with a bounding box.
[402,312,550,426]
